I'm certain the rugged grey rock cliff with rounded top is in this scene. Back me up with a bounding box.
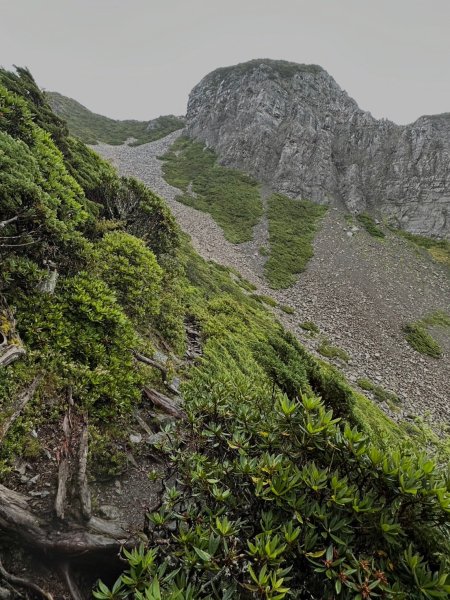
[187,60,450,237]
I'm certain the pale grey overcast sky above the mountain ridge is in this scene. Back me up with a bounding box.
[0,0,450,123]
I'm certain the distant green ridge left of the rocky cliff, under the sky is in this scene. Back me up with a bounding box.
[46,92,184,145]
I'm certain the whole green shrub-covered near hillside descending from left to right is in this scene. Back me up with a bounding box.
[0,70,450,600]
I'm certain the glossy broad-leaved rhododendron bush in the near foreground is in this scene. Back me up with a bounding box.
[94,380,450,600]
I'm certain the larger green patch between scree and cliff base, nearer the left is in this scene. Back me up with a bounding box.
[163,138,263,244]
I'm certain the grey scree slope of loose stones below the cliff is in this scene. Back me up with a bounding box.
[94,131,450,422]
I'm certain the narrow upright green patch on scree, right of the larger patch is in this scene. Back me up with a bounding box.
[264,194,327,289]
